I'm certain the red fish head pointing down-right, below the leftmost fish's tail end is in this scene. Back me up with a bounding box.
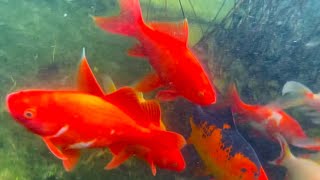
[154,149,186,172]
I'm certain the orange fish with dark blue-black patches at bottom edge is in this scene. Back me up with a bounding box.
[188,106,268,180]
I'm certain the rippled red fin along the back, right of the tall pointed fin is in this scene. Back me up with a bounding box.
[104,87,161,127]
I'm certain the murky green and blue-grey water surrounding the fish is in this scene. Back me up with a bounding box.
[0,0,320,180]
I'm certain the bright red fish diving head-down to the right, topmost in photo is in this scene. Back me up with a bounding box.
[93,0,216,105]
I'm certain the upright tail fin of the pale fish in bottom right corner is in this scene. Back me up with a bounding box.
[270,134,294,165]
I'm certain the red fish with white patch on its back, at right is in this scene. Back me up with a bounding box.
[229,85,320,150]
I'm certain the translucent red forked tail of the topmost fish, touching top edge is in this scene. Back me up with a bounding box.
[93,0,144,36]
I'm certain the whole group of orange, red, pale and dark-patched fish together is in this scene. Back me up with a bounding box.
[6,0,320,180]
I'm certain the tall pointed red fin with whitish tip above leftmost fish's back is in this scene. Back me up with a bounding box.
[77,48,104,97]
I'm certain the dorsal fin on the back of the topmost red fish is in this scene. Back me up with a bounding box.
[148,19,189,44]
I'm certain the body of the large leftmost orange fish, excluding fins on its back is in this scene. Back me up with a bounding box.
[7,90,184,170]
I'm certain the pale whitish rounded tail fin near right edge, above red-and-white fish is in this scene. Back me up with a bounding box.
[282,81,312,95]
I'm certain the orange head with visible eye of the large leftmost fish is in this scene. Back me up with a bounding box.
[6,90,63,136]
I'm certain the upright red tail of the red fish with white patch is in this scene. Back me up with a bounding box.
[228,83,250,113]
